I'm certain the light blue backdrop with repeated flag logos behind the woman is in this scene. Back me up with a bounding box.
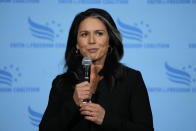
[0,0,196,131]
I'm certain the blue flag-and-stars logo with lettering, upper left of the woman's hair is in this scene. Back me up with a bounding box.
[10,17,66,48]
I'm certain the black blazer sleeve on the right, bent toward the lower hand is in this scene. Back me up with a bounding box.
[102,71,154,131]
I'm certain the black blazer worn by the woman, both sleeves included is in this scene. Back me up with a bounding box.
[39,66,154,131]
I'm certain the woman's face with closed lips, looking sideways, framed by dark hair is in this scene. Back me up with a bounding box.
[76,17,109,62]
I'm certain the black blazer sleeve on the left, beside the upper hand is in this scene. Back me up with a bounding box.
[39,76,79,131]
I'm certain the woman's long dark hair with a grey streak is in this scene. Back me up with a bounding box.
[65,8,124,83]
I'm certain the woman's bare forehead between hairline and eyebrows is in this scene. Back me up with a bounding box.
[78,17,106,30]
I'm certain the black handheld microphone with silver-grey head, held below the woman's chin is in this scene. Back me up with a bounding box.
[82,57,92,103]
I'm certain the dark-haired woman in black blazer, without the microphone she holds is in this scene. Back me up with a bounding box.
[39,8,154,131]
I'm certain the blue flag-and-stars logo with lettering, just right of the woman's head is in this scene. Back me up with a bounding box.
[117,18,169,48]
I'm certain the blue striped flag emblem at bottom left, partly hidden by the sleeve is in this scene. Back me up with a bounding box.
[28,106,43,127]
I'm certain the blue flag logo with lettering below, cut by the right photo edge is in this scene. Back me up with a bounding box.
[149,62,196,93]
